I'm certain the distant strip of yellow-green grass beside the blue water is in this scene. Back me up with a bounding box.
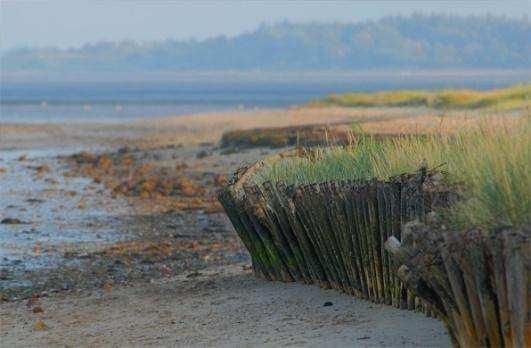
[312,84,531,110]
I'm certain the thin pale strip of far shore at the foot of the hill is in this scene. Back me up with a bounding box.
[0,68,531,83]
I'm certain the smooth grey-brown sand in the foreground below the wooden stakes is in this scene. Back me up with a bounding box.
[0,265,450,347]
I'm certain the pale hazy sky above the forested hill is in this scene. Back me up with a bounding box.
[0,0,531,49]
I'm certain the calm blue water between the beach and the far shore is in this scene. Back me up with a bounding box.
[0,77,528,123]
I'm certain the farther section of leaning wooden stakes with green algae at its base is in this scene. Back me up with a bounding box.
[219,154,449,314]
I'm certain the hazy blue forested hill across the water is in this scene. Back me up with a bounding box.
[2,15,531,72]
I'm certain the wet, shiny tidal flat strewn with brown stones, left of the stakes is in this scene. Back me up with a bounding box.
[0,141,263,300]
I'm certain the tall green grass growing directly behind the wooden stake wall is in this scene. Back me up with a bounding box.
[254,117,531,227]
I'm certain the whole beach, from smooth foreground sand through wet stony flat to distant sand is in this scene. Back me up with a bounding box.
[0,107,511,346]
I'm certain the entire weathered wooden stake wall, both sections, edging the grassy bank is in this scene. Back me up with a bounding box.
[219,151,531,347]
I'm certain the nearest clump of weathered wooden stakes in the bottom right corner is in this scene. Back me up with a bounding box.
[386,224,531,347]
